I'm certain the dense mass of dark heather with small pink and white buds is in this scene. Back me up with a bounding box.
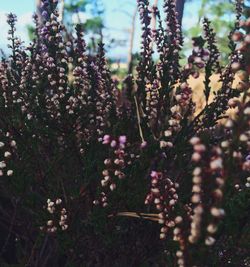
[0,0,250,267]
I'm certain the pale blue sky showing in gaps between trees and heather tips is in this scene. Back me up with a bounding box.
[0,0,201,57]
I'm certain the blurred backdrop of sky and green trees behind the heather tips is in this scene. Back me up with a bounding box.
[0,0,249,63]
